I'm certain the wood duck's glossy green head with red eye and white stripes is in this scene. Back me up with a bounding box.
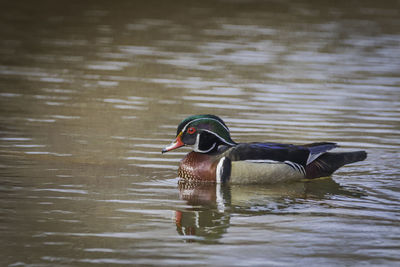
[162,115,236,153]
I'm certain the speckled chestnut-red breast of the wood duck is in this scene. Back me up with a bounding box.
[178,151,218,181]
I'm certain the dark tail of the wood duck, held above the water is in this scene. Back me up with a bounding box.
[306,151,367,179]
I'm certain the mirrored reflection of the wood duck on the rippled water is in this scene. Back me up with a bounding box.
[175,178,363,243]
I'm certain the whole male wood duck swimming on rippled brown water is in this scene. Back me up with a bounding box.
[162,115,367,184]
